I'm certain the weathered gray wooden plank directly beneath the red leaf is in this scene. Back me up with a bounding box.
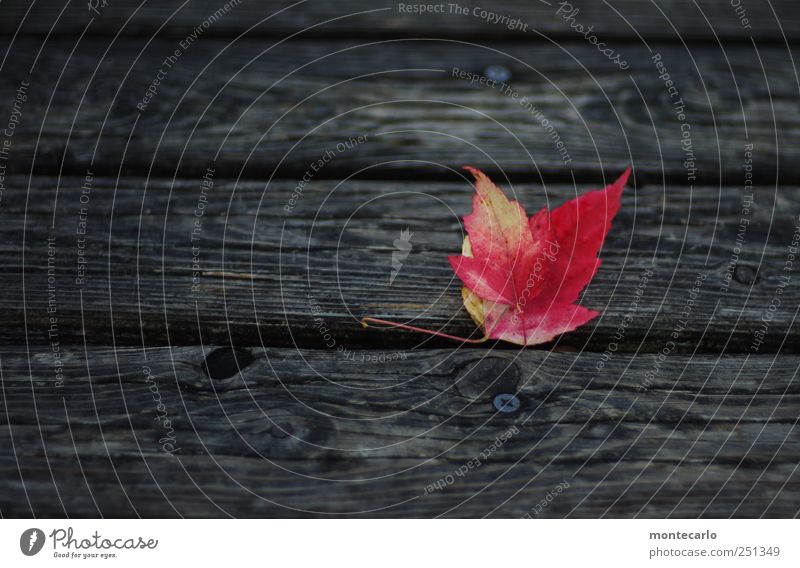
[0,173,800,353]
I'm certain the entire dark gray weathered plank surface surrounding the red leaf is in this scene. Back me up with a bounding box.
[0,0,800,518]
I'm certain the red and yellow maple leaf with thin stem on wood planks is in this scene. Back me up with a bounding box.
[362,167,630,345]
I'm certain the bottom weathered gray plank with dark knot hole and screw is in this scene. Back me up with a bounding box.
[0,346,800,517]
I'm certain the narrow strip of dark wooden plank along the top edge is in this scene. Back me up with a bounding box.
[0,0,800,41]
